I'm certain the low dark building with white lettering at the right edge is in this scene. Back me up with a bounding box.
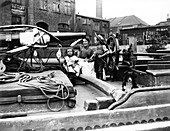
[120,25,170,45]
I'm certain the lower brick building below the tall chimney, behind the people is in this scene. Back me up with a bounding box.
[75,14,110,44]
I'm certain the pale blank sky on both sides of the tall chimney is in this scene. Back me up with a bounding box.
[75,0,170,25]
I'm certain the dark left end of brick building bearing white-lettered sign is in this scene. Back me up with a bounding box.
[0,0,29,25]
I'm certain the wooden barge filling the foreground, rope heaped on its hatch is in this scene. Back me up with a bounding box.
[0,25,170,131]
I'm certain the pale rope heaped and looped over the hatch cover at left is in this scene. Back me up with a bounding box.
[0,72,70,111]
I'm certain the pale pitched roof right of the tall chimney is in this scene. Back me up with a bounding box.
[108,15,148,33]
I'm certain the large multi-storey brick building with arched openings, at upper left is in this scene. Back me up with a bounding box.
[0,0,75,31]
